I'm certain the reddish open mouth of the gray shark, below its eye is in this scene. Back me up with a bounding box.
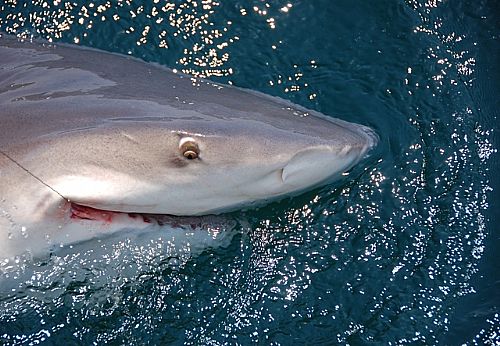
[70,202,236,230]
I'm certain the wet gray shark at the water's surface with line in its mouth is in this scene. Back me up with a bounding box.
[0,35,377,258]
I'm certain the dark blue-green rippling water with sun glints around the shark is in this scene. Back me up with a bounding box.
[0,0,500,345]
